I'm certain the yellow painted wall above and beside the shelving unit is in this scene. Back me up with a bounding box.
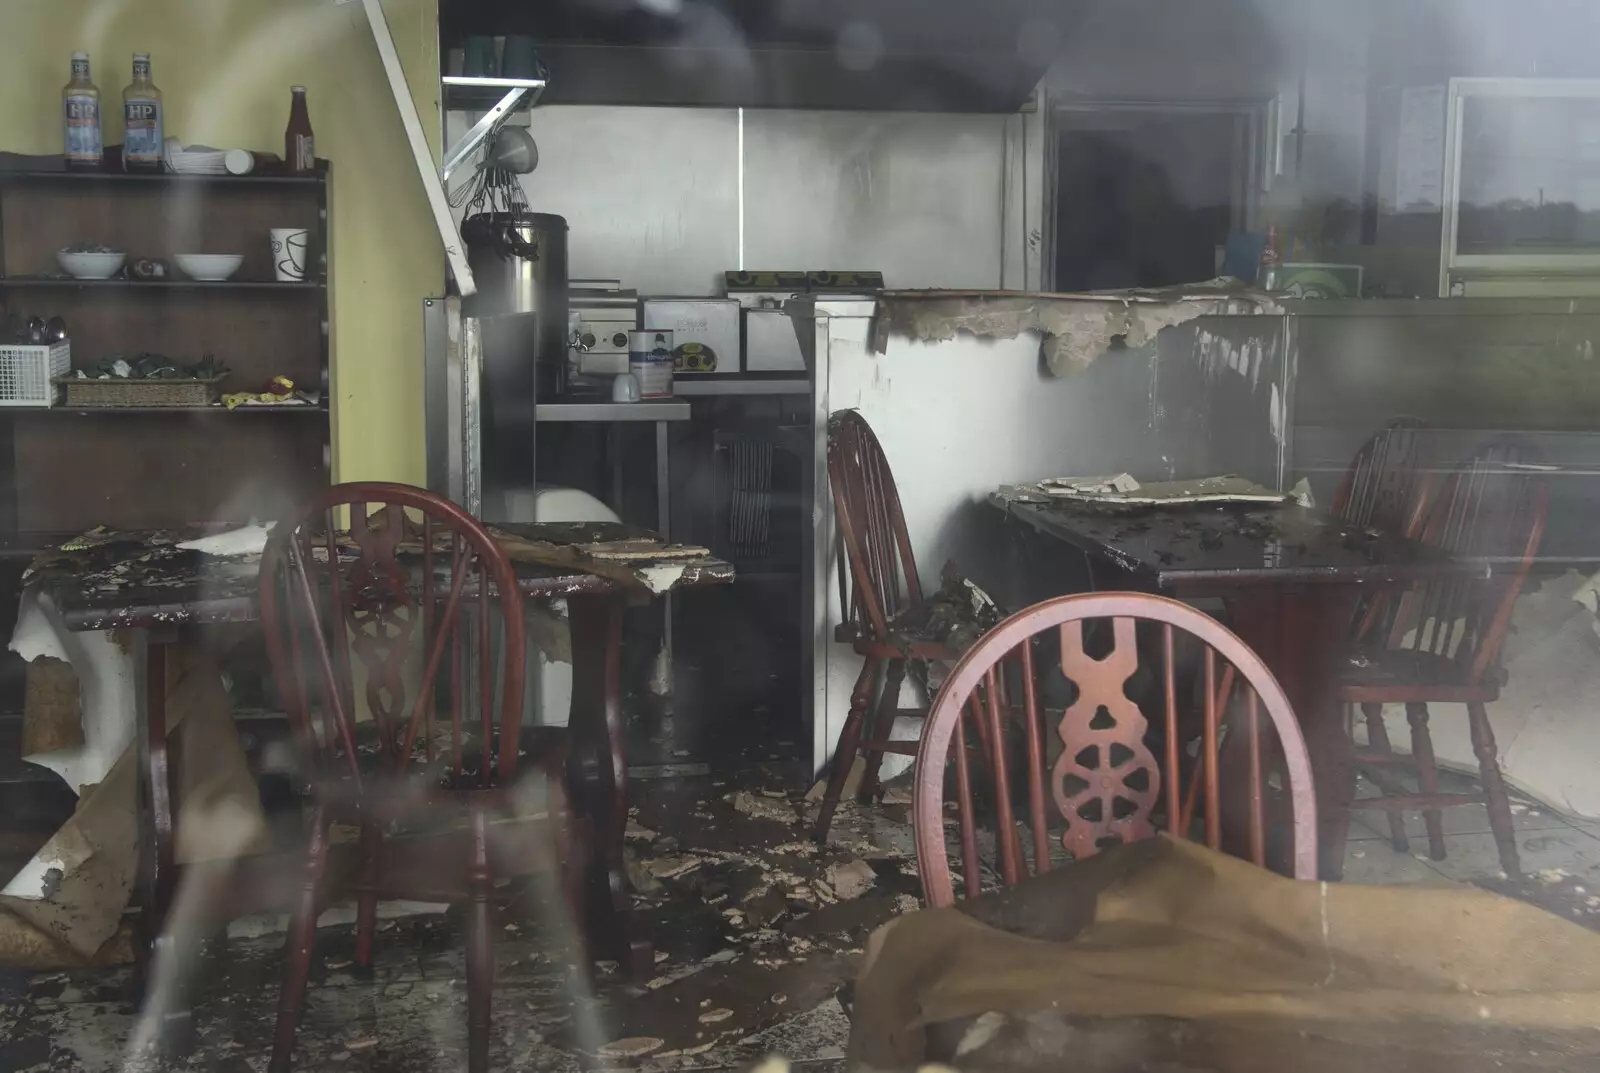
[0,0,445,485]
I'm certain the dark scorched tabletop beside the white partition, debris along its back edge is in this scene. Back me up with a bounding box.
[989,491,1490,588]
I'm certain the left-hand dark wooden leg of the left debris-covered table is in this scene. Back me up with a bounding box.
[131,628,194,1052]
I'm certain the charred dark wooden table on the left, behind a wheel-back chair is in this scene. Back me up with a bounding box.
[29,525,734,1017]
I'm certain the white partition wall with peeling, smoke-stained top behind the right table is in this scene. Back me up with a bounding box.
[811,302,1290,777]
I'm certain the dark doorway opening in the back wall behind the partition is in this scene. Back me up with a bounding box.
[1053,104,1267,293]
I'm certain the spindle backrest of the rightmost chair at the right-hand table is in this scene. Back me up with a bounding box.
[1381,437,1550,684]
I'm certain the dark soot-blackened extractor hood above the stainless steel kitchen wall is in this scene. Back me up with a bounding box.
[440,0,1082,112]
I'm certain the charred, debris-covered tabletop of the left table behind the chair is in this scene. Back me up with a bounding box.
[27,526,734,630]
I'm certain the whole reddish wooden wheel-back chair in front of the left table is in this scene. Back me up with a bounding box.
[261,485,582,1073]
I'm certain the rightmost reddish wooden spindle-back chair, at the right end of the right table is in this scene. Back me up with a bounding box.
[1339,438,1549,875]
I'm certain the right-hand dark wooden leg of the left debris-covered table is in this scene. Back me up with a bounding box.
[566,593,653,979]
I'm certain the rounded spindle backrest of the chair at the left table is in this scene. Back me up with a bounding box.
[261,483,523,787]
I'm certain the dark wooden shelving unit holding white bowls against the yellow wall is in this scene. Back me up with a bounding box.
[0,163,331,558]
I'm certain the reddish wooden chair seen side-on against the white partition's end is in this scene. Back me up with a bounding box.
[816,409,960,841]
